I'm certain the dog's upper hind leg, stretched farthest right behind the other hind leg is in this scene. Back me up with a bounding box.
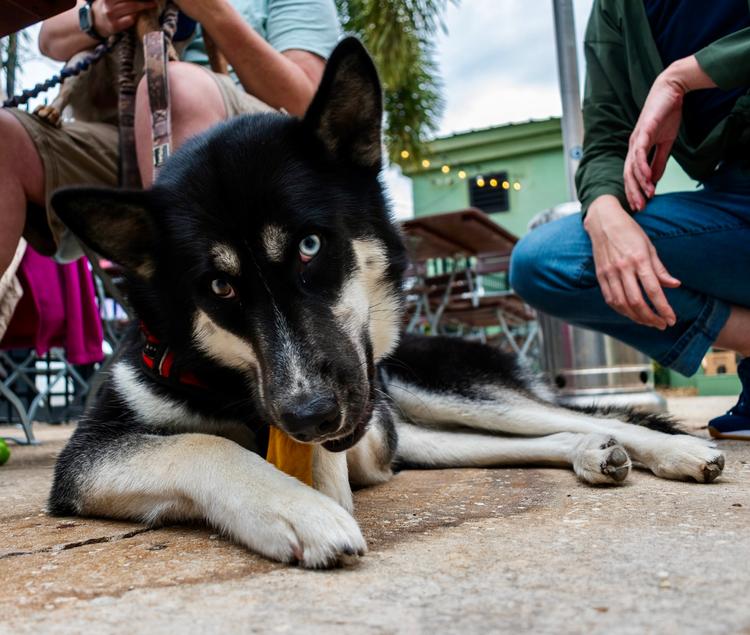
[389,380,724,483]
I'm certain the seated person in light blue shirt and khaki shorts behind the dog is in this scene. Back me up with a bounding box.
[0,0,339,274]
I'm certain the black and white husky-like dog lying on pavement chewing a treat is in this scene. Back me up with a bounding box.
[49,39,724,567]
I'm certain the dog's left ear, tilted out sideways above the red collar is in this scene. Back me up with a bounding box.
[51,187,156,278]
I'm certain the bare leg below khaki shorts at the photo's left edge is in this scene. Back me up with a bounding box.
[0,111,44,275]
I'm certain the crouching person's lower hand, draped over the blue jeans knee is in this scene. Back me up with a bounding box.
[584,195,680,330]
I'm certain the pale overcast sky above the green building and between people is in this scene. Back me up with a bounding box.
[14,0,593,217]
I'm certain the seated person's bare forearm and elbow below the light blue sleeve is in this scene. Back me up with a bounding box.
[178,0,325,115]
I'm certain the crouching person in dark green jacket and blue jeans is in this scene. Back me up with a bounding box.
[511,0,750,439]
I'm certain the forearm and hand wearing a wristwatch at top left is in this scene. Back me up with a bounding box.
[39,0,156,62]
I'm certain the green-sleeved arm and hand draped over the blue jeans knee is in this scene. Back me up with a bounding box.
[576,1,680,329]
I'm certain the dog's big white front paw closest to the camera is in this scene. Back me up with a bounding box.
[232,484,367,569]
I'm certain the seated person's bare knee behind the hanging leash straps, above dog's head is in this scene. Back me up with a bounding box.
[135,62,227,187]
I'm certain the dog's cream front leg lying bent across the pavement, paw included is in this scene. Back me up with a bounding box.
[50,434,366,568]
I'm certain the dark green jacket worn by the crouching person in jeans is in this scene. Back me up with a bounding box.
[576,0,750,212]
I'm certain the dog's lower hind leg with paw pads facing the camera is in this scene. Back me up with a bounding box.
[396,423,630,485]
